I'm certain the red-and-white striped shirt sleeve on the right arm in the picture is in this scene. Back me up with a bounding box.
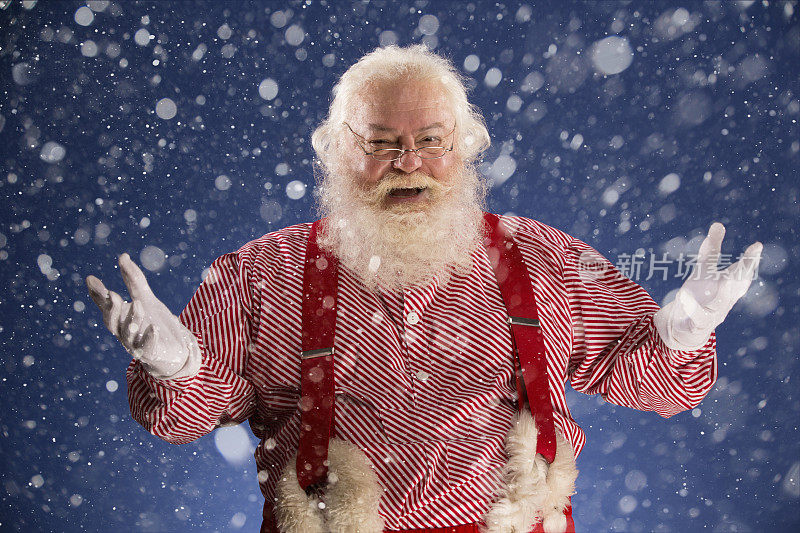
[564,239,717,418]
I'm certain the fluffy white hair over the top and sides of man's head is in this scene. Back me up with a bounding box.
[311,44,490,177]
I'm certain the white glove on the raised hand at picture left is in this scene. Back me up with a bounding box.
[86,254,201,379]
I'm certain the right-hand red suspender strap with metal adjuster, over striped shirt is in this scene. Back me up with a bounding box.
[484,213,556,463]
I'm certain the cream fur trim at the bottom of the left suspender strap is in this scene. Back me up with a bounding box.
[275,439,383,533]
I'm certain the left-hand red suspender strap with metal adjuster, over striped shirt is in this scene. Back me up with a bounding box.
[296,220,338,491]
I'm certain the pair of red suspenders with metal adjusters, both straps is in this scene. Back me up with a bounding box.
[297,213,556,491]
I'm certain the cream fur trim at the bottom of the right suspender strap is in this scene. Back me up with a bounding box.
[483,409,578,533]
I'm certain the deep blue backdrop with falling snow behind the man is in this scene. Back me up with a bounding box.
[0,0,800,532]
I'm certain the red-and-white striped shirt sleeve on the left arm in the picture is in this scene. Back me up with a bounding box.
[127,253,255,444]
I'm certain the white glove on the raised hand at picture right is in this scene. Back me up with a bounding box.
[653,222,763,351]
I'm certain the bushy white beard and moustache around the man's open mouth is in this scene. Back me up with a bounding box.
[319,161,486,290]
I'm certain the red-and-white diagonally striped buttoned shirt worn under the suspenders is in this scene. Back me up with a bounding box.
[128,217,717,529]
